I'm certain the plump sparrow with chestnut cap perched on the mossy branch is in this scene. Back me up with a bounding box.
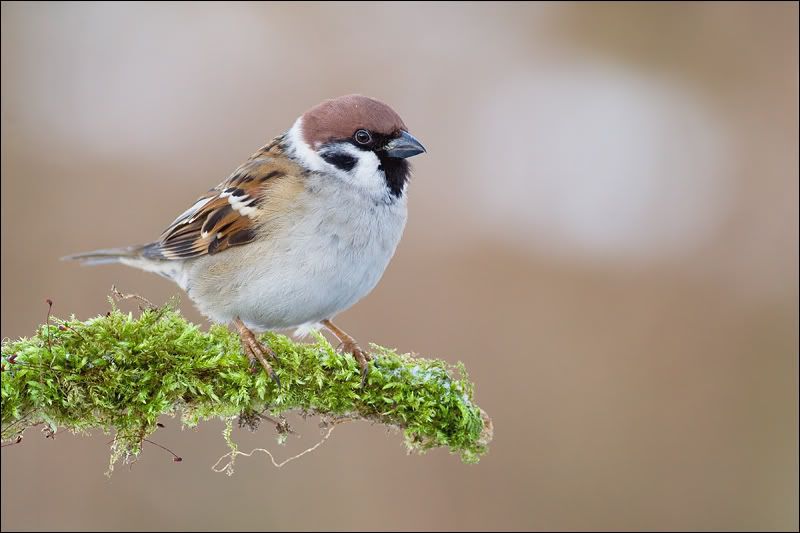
[63,94,426,387]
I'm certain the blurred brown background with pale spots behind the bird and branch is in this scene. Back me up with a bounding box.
[1,2,798,530]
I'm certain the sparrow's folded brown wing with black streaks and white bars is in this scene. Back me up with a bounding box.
[144,137,303,259]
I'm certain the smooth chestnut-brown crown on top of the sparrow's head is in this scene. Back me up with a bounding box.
[303,94,406,148]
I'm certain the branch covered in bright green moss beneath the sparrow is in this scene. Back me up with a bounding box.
[2,300,492,466]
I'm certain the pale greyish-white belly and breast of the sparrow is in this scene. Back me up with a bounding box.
[184,185,406,331]
